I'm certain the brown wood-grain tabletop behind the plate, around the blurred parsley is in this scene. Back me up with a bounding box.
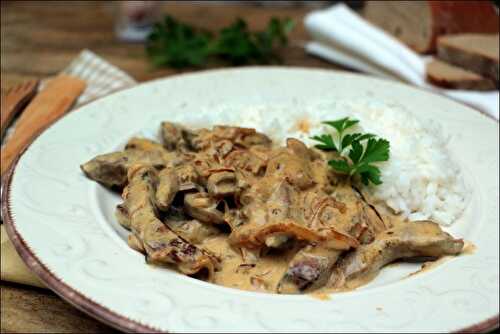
[1,1,338,94]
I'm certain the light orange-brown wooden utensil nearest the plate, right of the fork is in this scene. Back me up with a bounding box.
[0,75,86,177]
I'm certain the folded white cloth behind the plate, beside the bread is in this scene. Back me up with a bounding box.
[304,4,499,120]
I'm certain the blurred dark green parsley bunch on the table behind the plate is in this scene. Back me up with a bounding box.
[146,16,294,68]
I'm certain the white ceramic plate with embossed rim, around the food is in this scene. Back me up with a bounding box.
[3,67,499,332]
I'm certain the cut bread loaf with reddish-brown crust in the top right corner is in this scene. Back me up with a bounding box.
[363,1,499,53]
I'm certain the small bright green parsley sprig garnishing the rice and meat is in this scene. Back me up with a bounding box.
[312,117,390,185]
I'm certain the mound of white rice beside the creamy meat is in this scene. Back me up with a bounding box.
[184,101,467,225]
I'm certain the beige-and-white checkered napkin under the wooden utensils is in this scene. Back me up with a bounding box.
[0,50,136,288]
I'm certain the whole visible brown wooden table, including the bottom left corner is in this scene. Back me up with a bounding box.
[0,1,344,333]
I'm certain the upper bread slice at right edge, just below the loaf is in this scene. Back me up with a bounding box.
[437,34,500,87]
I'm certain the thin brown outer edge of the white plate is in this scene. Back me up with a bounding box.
[1,66,500,333]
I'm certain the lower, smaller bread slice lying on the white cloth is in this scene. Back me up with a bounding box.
[427,59,495,91]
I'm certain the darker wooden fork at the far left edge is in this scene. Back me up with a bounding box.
[0,80,39,140]
